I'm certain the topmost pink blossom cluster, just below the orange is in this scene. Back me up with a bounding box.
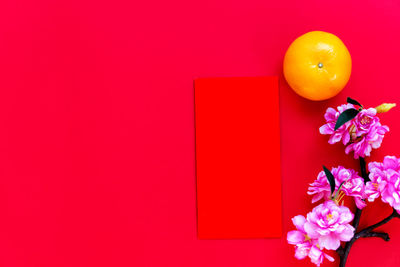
[319,104,389,159]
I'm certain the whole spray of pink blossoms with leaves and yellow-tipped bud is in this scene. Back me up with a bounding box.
[287,98,400,266]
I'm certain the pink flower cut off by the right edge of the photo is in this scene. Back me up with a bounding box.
[365,156,400,211]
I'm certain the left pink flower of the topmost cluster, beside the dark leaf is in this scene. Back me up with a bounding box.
[319,104,354,145]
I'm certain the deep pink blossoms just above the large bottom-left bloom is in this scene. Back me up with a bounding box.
[307,166,366,209]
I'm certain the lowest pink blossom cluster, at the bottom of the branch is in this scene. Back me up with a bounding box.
[287,200,354,266]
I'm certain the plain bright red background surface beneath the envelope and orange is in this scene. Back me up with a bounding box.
[0,0,400,267]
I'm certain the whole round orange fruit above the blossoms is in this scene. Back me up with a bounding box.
[283,31,351,100]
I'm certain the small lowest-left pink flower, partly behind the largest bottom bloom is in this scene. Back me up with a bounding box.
[287,215,334,266]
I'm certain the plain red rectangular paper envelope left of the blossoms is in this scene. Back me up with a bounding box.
[195,77,282,239]
